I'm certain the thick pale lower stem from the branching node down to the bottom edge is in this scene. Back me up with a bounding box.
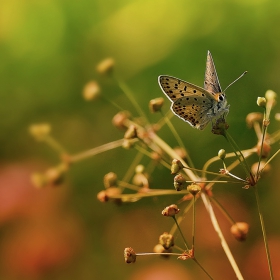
[201,193,244,280]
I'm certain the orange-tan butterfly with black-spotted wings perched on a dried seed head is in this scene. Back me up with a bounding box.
[158,51,229,130]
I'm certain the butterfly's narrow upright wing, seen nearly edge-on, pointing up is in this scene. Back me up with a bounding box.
[204,51,222,93]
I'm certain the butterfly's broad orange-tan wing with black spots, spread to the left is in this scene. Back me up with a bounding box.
[159,76,219,130]
